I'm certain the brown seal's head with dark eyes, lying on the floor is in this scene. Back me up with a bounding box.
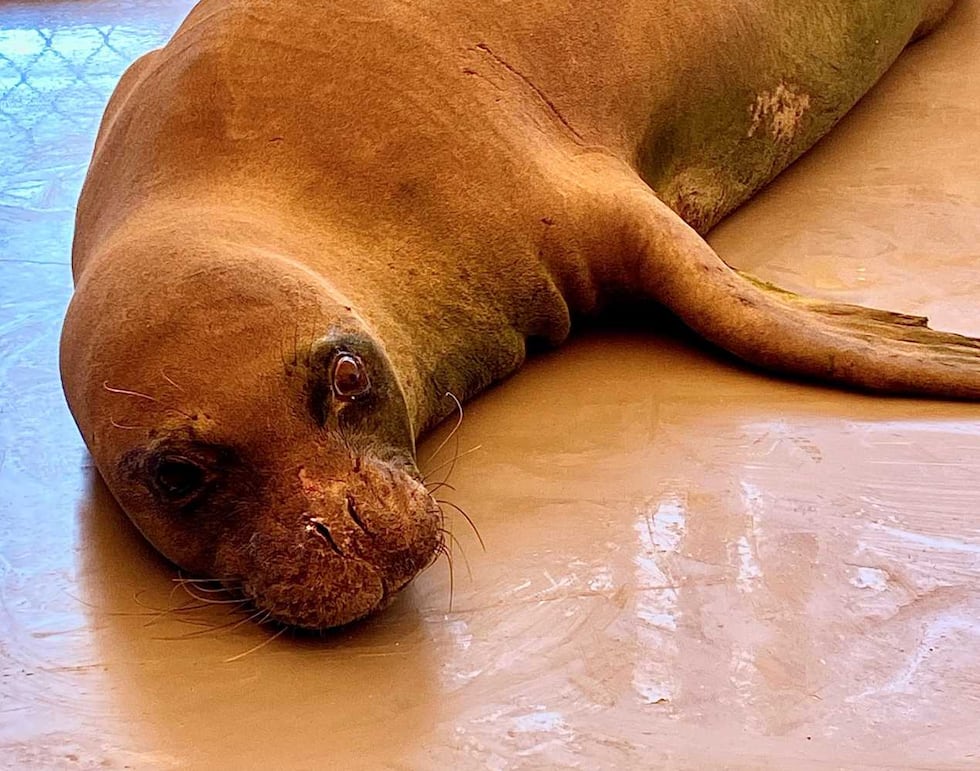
[62,228,441,629]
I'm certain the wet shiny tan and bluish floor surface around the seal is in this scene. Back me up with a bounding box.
[0,0,980,769]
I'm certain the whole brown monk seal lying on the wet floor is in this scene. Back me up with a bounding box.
[61,0,980,629]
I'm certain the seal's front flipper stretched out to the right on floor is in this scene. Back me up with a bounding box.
[625,191,980,399]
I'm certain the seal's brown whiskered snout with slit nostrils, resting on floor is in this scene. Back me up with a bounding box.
[232,460,441,629]
